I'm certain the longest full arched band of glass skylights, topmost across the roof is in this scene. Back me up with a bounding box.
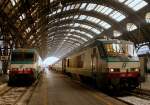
[49,3,126,22]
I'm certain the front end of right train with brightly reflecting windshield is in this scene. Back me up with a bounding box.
[104,40,140,90]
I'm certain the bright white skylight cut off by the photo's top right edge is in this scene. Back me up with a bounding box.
[124,0,148,11]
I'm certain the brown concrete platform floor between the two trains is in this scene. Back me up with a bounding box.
[29,70,125,105]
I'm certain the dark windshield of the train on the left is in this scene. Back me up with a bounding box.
[11,52,34,62]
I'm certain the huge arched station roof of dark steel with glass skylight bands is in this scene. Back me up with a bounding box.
[0,0,150,58]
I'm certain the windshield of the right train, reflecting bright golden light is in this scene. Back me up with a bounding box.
[104,43,137,57]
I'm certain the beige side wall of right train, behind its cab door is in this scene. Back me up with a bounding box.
[66,49,91,76]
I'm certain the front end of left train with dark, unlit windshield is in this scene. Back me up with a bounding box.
[9,50,35,83]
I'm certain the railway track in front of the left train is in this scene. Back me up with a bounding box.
[0,77,39,105]
